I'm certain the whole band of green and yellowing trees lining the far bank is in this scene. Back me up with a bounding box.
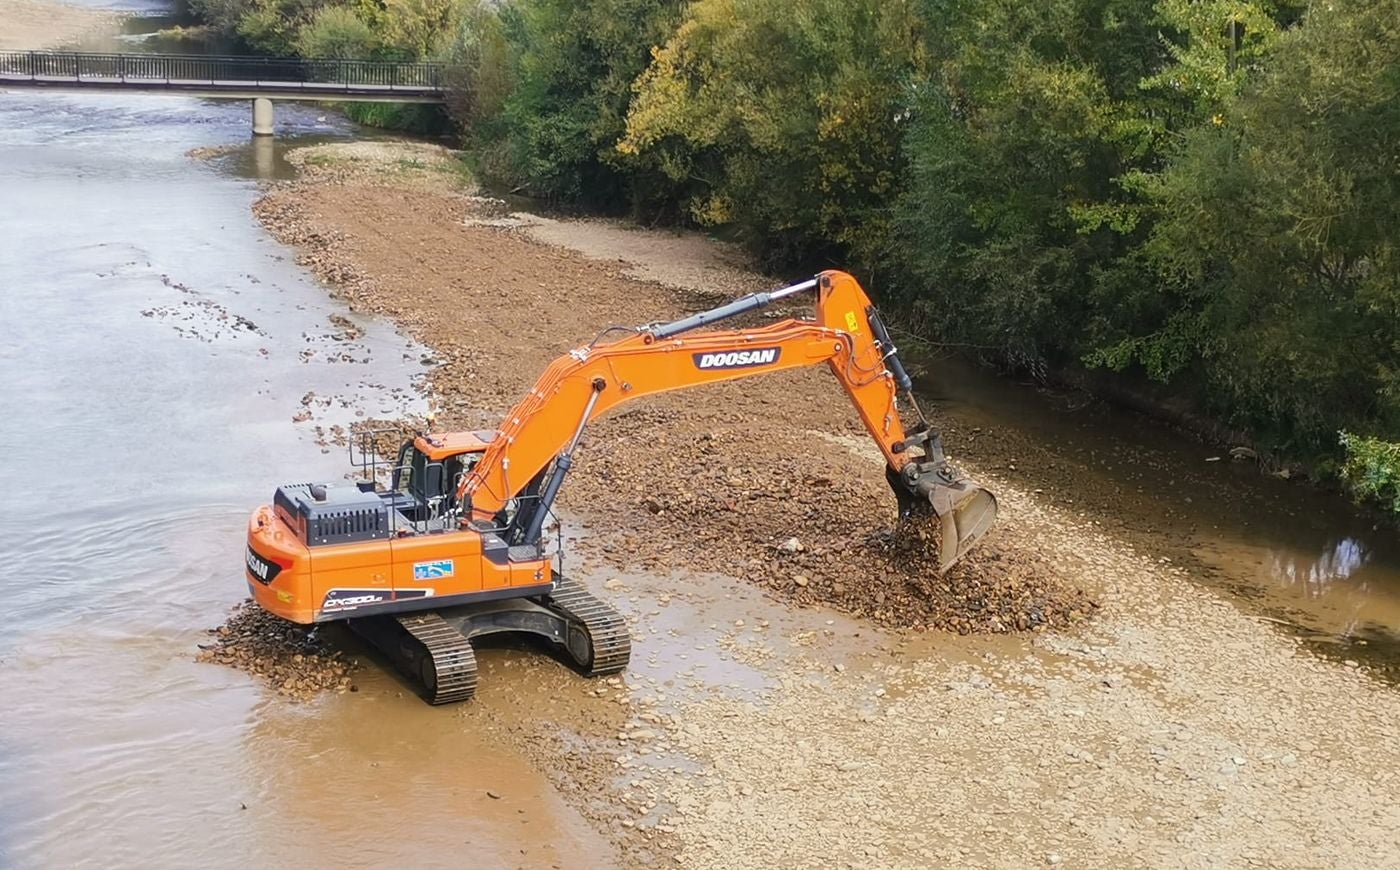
[190,0,1400,487]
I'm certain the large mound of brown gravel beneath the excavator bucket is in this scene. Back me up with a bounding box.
[566,414,1095,635]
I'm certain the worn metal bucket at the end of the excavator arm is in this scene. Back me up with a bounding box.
[886,448,997,573]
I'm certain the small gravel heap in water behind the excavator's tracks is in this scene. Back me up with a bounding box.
[196,598,356,700]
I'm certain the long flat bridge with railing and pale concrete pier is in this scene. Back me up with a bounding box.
[0,52,444,136]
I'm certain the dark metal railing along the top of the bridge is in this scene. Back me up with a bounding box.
[0,52,442,91]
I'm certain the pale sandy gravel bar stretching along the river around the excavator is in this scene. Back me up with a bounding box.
[240,149,1400,867]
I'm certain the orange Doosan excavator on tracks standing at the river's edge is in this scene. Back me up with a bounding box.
[246,272,997,703]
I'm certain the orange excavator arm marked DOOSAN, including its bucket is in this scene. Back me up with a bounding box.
[458,272,997,569]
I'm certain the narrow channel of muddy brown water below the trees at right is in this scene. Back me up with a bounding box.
[918,357,1400,664]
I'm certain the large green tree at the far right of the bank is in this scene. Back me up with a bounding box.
[1096,0,1400,451]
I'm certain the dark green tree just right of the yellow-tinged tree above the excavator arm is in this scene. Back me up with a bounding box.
[892,0,1168,367]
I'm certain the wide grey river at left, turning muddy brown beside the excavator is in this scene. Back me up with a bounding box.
[0,83,609,867]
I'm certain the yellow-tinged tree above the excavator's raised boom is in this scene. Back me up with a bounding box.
[617,0,923,265]
